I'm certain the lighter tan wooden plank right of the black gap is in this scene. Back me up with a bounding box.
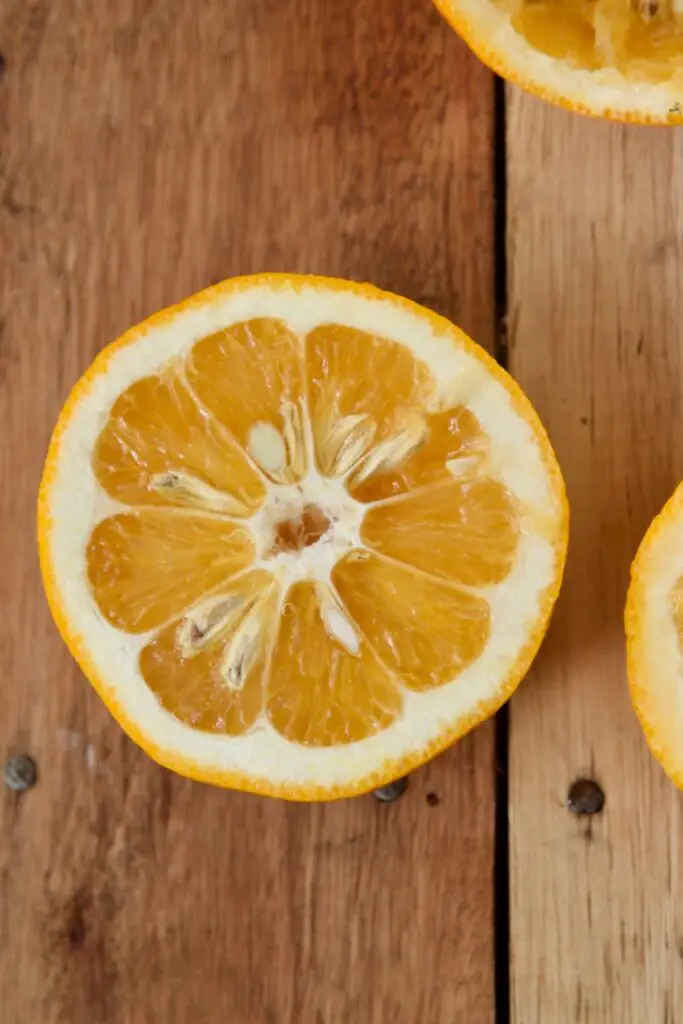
[508,90,683,1024]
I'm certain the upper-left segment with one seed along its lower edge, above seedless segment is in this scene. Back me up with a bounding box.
[92,366,265,516]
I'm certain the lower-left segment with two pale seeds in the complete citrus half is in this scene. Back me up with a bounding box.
[140,571,278,736]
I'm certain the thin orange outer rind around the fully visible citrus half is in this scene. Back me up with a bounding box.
[38,274,568,801]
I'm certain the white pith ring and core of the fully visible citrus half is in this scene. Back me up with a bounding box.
[49,286,562,787]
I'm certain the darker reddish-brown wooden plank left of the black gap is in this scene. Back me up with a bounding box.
[0,0,494,1024]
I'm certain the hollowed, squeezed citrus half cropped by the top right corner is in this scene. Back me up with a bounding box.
[434,0,683,124]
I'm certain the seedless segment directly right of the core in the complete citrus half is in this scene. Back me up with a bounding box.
[360,478,519,587]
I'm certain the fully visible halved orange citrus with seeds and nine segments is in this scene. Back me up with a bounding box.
[39,275,567,800]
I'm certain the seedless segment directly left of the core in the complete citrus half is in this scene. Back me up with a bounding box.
[86,509,255,633]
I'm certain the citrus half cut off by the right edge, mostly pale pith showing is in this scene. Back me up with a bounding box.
[626,483,683,788]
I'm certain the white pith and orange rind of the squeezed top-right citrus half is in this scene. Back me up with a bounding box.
[436,0,683,122]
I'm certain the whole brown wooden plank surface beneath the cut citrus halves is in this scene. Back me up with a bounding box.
[0,0,683,1024]
